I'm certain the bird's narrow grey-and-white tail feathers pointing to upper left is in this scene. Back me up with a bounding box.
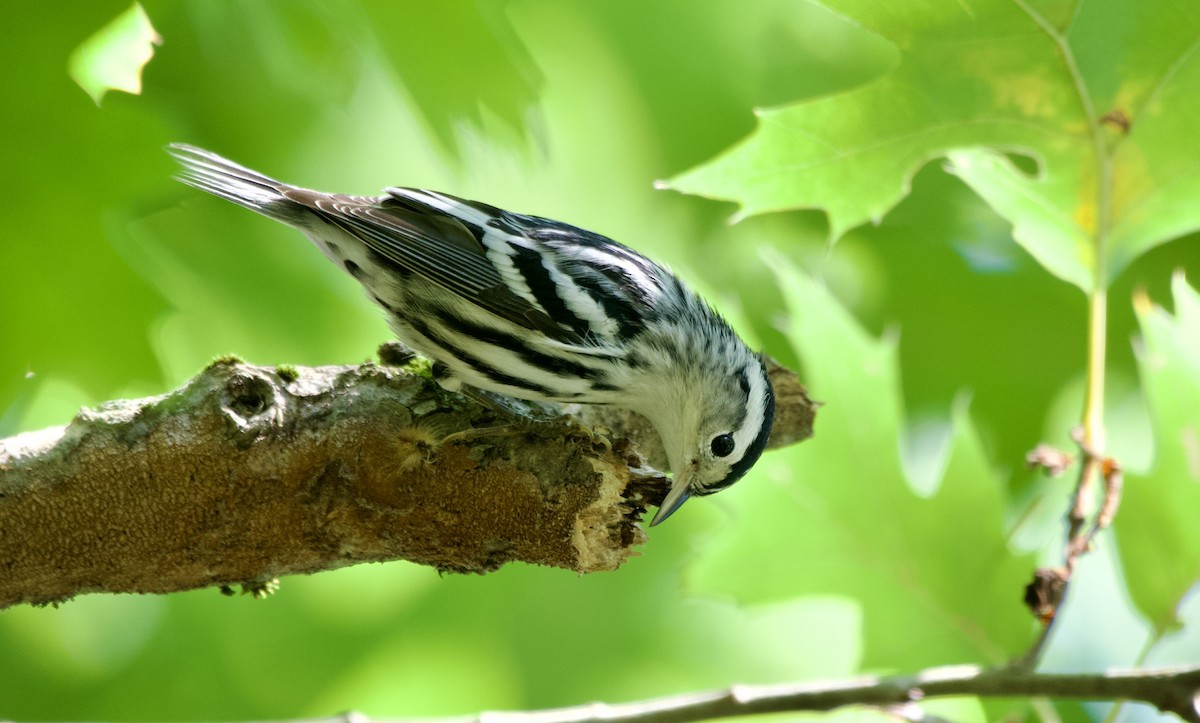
[167,143,306,225]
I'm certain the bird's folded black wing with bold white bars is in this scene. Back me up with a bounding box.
[284,189,665,353]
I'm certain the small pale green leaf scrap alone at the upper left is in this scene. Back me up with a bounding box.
[67,2,162,106]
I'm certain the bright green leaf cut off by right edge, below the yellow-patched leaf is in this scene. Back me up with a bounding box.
[1116,274,1200,632]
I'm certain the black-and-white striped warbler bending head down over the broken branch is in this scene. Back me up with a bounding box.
[169,144,775,525]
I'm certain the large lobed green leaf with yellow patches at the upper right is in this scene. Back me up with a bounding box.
[668,0,1200,291]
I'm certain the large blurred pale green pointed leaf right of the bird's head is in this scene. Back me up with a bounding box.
[691,258,1033,668]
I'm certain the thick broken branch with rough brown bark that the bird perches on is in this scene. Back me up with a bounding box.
[0,350,811,608]
